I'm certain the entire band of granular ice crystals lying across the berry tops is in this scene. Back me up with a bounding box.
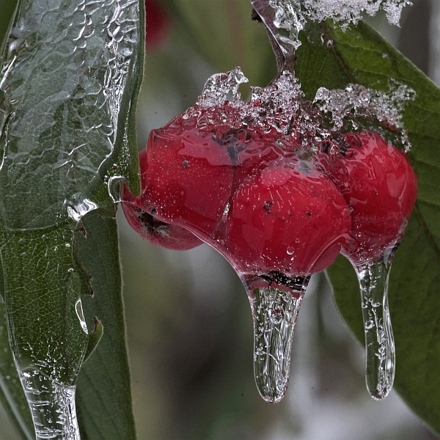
[188,67,415,150]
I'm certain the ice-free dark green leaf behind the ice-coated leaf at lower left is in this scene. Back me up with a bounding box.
[77,211,135,440]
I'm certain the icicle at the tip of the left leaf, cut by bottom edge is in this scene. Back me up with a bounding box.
[19,369,80,440]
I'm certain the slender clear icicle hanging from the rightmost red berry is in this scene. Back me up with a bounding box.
[355,259,396,400]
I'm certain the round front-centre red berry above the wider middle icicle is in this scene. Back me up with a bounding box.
[223,162,350,276]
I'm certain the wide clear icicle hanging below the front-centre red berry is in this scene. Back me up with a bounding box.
[242,275,308,403]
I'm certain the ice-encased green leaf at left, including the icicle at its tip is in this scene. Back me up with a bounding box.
[0,0,142,440]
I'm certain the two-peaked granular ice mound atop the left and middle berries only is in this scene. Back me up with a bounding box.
[187,68,331,149]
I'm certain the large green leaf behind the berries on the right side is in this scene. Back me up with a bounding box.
[296,22,440,433]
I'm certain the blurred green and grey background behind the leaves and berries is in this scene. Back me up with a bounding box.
[0,0,440,440]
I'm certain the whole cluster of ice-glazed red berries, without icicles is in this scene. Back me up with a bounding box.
[122,96,417,284]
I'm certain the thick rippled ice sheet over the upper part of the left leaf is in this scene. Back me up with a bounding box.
[0,0,140,228]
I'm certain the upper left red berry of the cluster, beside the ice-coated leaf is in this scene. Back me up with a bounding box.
[138,111,233,236]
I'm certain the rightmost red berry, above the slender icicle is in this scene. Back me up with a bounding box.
[322,132,417,265]
